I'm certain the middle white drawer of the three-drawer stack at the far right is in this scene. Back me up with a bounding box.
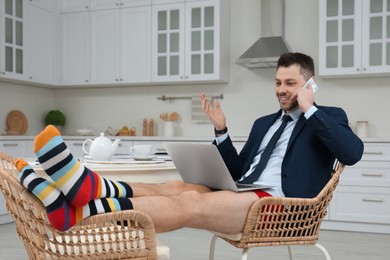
[340,161,390,187]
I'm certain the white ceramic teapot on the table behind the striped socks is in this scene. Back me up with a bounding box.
[83,133,121,161]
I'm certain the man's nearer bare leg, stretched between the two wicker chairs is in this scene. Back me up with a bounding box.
[131,191,258,234]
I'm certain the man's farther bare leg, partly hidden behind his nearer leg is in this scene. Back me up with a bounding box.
[128,180,211,197]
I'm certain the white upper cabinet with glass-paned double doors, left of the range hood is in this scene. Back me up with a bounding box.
[152,0,230,82]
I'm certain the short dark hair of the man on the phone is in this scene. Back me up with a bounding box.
[276,52,315,79]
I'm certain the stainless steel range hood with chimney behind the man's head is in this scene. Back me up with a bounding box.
[236,0,290,68]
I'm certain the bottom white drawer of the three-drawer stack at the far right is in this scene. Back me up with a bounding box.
[330,186,390,224]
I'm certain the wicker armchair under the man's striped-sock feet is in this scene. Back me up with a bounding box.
[0,151,157,260]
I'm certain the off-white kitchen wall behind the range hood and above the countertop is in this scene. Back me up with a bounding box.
[0,0,390,137]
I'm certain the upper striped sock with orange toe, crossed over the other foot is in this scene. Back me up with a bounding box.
[34,125,133,207]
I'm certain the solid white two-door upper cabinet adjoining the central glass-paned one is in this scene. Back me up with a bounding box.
[90,5,151,84]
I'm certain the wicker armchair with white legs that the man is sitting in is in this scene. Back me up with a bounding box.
[209,164,344,260]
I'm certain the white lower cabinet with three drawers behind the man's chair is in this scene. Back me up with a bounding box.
[329,142,390,233]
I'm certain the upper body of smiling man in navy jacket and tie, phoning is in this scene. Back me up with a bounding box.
[202,53,363,198]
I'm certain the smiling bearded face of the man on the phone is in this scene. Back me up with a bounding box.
[275,64,306,111]
